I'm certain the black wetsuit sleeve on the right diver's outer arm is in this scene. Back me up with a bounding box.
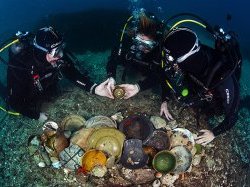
[212,75,240,136]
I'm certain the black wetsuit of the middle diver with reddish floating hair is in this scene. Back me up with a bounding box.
[106,36,161,91]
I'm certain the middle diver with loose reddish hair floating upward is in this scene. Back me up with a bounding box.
[106,9,164,99]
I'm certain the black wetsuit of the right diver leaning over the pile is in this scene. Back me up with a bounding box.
[162,45,241,136]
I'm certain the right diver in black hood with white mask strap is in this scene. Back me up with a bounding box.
[161,23,242,145]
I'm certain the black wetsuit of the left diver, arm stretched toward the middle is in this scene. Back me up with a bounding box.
[7,46,96,119]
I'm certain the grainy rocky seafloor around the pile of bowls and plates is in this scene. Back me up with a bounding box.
[0,51,250,187]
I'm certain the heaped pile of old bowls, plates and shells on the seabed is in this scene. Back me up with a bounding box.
[28,113,204,185]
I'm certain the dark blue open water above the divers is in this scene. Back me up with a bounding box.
[0,0,250,57]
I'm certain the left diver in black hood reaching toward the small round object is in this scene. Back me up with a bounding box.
[7,27,111,122]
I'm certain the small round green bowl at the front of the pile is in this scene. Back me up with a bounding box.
[152,150,176,174]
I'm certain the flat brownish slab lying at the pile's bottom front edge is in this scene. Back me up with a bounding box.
[122,169,155,185]
